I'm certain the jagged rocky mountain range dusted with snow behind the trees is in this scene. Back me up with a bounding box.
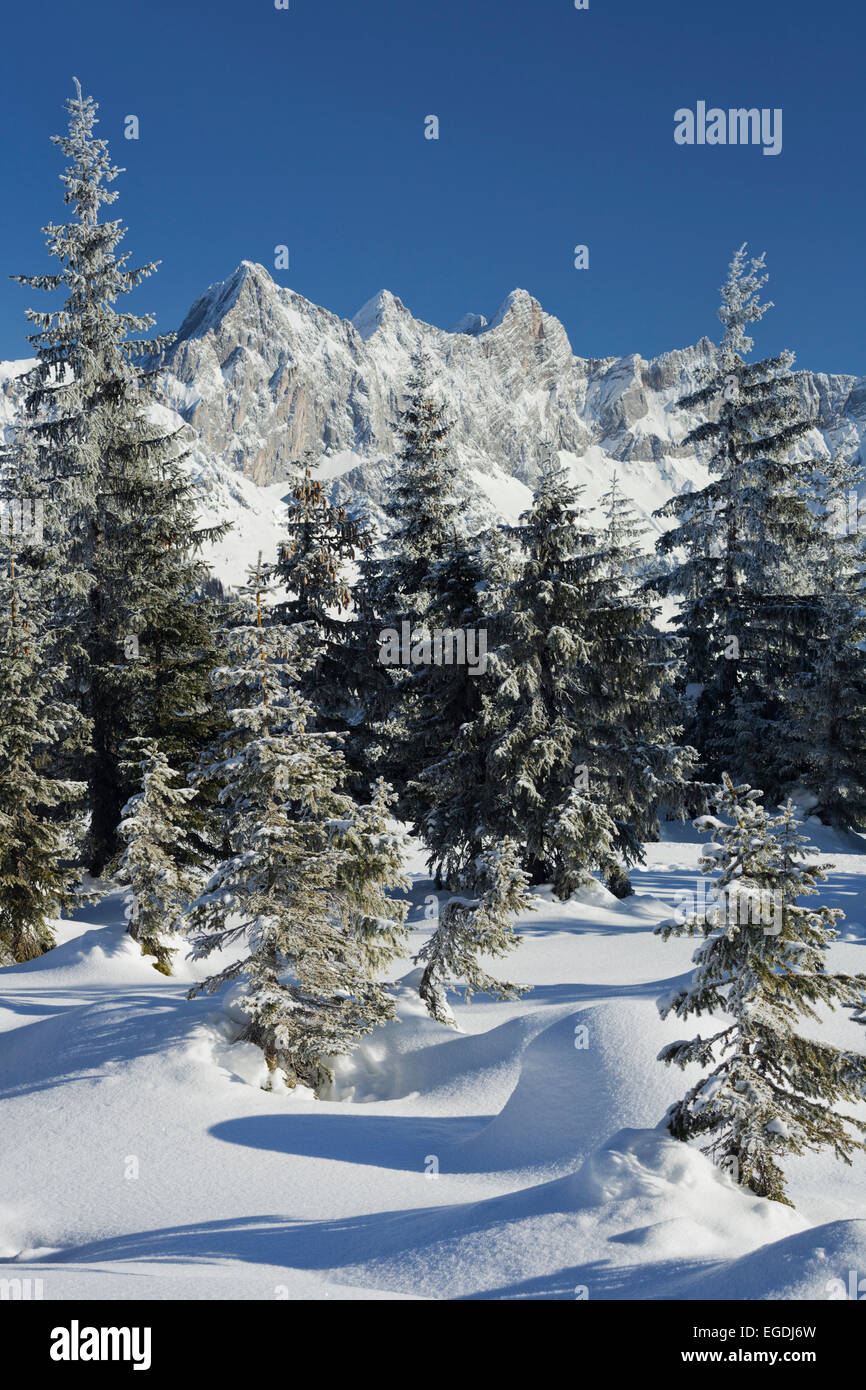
[0,261,866,578]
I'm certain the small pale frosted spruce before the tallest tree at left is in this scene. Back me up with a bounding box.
[117,738,204,974]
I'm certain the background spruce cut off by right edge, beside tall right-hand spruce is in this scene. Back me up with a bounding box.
[783,455,866,830]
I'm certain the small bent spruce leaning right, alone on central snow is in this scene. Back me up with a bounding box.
[416,840,534,1027]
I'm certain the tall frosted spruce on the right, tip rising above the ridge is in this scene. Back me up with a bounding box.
[652,246,813,794]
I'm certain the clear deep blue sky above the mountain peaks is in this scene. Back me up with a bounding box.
[0,0,866,374]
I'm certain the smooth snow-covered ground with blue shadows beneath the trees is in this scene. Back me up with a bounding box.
[0,824,866,1300]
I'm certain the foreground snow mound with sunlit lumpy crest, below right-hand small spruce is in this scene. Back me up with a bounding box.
[309,1130,800,1300]
